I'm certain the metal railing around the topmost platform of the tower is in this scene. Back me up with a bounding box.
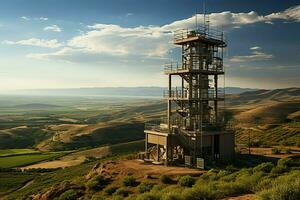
[173,26,224,41]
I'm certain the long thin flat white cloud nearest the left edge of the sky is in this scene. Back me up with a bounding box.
[2,38,63,48]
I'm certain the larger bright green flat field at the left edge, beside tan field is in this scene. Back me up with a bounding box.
[0,152,66,168]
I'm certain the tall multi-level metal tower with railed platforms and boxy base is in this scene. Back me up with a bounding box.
[145,25,234,165]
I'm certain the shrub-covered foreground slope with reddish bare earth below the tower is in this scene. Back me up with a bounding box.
[0,152,300,200]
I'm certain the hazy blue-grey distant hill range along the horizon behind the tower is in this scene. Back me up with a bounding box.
[7,87,257,97]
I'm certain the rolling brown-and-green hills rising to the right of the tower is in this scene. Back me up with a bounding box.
[227,88,300,146]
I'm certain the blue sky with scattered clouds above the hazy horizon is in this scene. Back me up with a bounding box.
[0,0,300,92]
